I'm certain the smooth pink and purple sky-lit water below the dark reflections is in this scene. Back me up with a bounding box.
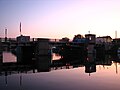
[0,64,120,90]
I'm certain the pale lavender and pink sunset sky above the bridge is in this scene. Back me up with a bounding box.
[0,0,120,39]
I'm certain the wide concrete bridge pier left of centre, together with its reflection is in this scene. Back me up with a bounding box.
[35,38,51,72]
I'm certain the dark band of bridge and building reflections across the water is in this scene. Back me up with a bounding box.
[0,52,120,75]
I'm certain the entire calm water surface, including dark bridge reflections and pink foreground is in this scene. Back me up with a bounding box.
[0,54,120,90]
